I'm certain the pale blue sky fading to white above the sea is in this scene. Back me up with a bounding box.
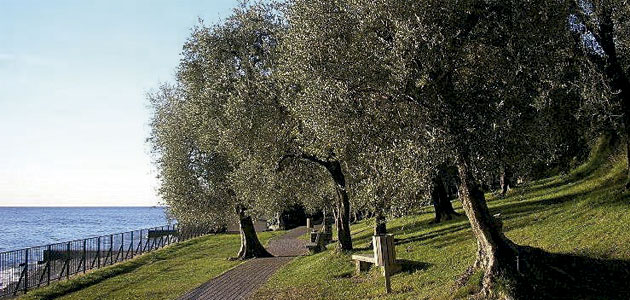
[0,0,238,206]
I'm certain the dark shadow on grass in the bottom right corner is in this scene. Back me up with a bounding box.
[518,246,630,299]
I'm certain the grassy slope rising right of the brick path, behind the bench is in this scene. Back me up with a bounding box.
[255,143,630,299]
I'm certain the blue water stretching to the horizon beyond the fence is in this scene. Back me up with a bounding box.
[0,207,167,252]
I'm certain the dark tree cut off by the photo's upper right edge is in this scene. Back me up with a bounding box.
[568,0,630,189]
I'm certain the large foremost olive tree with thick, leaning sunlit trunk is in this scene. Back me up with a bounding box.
[286,0,566,297]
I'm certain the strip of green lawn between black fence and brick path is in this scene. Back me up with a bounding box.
[20,232,280,300]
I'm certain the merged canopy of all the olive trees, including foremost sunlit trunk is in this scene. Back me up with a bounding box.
[149,0,630,297]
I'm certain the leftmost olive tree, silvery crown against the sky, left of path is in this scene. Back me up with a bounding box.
[154,3,289,259]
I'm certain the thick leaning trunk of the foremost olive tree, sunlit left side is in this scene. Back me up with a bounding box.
[457,154,517,299]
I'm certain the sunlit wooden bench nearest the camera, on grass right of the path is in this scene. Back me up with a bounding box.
[352,234,401,293]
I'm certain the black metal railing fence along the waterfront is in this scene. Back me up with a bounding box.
[0,225,206,298]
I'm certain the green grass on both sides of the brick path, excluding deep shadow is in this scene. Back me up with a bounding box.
[18,141,630,299]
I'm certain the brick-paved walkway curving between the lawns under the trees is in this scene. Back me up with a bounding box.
[179,227,308,300]
